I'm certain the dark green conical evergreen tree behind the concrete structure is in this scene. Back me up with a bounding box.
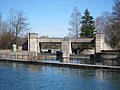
[80,9,95,38]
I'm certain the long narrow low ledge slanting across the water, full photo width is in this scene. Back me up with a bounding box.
[0,59,120,69]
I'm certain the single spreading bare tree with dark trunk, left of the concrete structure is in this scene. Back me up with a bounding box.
[8,9,29,43]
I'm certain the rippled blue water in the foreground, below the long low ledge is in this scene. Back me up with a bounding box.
[0,61,120,90]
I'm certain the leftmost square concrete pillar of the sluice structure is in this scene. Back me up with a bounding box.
[28,33,40,52]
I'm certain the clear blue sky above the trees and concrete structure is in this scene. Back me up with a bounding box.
[0,0,114,37]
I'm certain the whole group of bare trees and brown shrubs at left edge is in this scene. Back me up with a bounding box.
[0,9,30,49]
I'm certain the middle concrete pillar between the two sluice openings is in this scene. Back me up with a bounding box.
[62,38,72,57]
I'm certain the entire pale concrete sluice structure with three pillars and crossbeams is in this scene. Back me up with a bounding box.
[28,33,112,57]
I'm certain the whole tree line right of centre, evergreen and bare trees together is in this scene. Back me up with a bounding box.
[68,0,120,49]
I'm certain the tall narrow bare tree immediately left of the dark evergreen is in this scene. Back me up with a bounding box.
[69,7,81,38]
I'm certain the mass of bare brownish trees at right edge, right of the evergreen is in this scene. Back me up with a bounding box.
[96,0,120,48]
